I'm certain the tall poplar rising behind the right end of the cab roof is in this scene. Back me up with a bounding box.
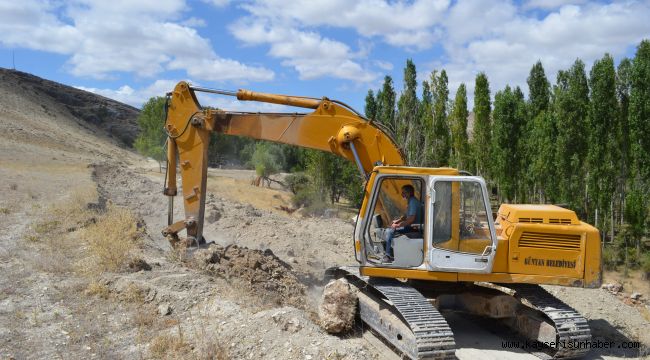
[472,73,492,176]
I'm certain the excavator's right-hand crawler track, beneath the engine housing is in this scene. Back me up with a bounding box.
[500,284,591,359]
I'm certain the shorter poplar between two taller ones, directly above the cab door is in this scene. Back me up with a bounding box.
[449,84,470,169]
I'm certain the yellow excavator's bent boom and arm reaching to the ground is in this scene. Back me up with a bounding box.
[163,82,404,244]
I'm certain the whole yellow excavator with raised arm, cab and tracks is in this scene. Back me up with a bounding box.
[163,82,602,359]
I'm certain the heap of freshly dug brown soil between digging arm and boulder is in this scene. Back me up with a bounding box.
[193,245,306,308]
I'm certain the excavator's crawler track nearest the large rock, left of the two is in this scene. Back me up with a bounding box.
[338,268,456,359]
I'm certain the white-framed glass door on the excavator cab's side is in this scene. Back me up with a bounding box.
[426,176,497,273]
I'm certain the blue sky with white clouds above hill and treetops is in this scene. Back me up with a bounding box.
[0,0,650,111]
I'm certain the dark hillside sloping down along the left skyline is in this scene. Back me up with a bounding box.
[0,67,140,147]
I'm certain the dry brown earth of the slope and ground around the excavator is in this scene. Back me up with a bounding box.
[0,69,650,359]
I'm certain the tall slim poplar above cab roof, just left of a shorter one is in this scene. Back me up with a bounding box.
[431,70,451,166]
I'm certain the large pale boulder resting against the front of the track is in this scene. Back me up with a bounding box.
[318,279,357,334]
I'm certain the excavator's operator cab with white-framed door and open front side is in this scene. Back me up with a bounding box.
[357,168,497,273]
